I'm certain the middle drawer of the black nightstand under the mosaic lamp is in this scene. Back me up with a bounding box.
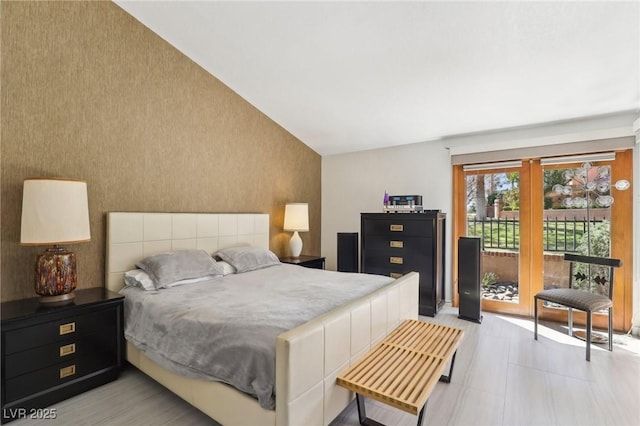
[5,330,117,379]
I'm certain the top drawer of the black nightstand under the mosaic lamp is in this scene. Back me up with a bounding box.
[4,309,117,355]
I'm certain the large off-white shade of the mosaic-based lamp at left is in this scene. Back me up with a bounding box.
[20,179,91,245]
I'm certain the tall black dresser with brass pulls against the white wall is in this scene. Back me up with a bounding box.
[360,210,446,316]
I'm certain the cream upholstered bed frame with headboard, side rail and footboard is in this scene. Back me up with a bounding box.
[106,212,418,425]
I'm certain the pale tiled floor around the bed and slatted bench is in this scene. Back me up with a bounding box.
[11,308,640,426]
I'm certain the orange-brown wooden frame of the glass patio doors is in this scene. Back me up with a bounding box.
[451,149,634,331]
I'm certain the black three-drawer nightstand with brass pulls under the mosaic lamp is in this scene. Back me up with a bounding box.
[0,288,125,423]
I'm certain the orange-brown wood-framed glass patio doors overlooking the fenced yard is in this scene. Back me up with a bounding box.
[453,150,633,329]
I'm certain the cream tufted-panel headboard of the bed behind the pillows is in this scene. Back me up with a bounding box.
[105,212,269,291]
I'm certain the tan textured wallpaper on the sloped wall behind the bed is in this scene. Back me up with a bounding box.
[0,1,321,301]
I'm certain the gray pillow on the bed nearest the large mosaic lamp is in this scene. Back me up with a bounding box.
[136,250,222,289]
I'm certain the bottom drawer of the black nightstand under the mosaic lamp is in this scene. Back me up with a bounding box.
[4,354,117,403]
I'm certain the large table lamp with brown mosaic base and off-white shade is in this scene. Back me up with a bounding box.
[20,178,91,305]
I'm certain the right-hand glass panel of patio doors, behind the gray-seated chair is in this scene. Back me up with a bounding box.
[541,155,631,328]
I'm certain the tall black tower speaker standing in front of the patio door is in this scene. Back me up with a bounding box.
[458,237,482,323]
